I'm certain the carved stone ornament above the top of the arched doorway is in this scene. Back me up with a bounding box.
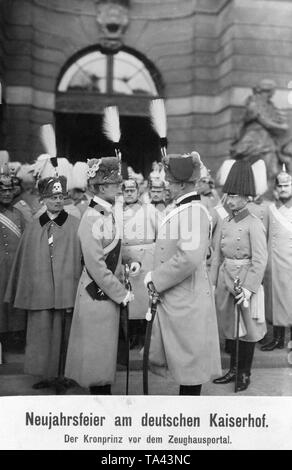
[96,1,129,50]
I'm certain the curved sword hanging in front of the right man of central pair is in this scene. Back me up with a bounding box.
[143,282,159,395]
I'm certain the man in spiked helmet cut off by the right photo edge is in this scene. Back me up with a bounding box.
[261,165,292,351]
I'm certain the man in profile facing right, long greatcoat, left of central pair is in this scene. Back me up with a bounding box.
[65,157,132,395]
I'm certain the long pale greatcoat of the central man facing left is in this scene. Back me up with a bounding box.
[149,195,221,385]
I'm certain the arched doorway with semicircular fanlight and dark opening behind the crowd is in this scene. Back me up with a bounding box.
[55,47,163,175]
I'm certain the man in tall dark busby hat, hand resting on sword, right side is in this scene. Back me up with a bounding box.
[211,160,267,391]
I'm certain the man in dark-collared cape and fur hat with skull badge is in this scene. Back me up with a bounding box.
[5,176,81,389]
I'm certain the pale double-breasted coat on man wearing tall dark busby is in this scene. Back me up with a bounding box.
[211,208,268,342]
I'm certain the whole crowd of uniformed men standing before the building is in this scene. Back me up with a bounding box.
[0,146,292,395]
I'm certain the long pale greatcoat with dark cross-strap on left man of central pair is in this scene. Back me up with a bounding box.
[65,197,127,387]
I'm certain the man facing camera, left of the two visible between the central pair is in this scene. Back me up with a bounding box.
[119,179,161,347]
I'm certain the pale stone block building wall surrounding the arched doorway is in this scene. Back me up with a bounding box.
[0,0,292,175]
